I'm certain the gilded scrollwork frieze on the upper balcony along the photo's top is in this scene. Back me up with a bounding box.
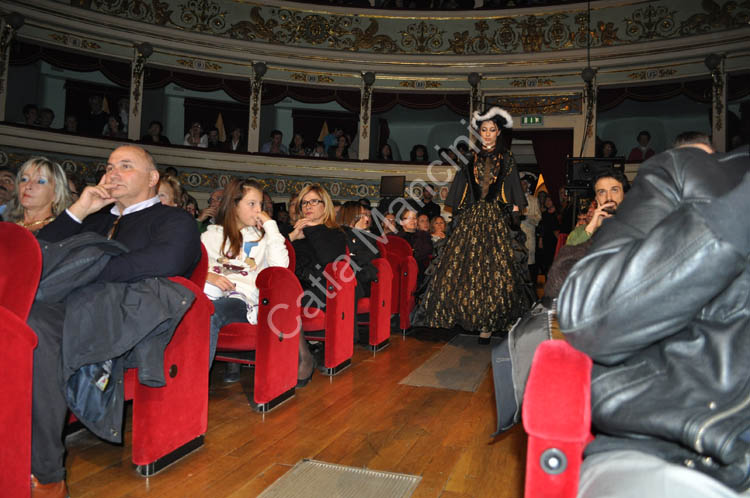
[83,0,750,55]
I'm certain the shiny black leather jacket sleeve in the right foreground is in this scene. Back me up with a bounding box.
[558,149,746,365]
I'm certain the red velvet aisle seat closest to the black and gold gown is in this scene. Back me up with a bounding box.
[386,235,419,332]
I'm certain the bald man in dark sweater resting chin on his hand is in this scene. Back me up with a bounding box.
[29,145,201,496]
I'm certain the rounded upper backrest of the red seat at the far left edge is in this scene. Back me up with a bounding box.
[0,222,42,322]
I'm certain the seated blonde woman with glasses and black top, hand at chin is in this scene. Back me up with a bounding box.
[289,184,346,313]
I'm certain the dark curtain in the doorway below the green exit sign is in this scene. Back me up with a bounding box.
[513,130,573,206]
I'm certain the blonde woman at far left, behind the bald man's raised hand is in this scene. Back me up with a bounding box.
[5,157,71,233]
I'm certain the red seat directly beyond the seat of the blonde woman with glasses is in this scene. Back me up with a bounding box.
[357,258,393,352]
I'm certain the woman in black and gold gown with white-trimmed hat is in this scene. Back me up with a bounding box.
[415,107,534,343]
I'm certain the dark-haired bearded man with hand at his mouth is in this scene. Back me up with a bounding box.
[566,168,630,246]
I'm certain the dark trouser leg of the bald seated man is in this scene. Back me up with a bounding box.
[28,303,68,484]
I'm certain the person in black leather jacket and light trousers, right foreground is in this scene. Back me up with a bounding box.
[558,146,750,498]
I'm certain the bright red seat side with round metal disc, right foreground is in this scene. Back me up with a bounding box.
[522,340,592,498]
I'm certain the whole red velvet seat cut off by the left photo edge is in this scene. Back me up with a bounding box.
[0,222,42,497]
